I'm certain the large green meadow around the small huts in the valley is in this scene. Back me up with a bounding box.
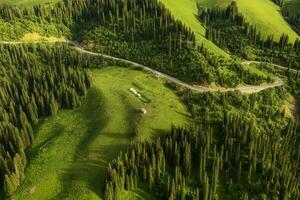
[15,67,188,200]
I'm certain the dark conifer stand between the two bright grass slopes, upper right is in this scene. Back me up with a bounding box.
[200,2,300,67]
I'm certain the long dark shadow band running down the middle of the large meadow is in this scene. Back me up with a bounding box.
[53,88,109,199]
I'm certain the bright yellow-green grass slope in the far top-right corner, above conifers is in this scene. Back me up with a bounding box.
[198,0,299,42]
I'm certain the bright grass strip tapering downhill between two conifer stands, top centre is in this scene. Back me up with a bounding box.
[159,0,228,57]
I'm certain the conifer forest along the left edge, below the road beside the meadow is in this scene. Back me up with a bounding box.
[0,45,91,196]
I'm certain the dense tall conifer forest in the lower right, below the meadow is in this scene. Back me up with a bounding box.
[104,113,300,200]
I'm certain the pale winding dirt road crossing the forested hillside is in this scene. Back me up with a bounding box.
[0,40,288,93]
